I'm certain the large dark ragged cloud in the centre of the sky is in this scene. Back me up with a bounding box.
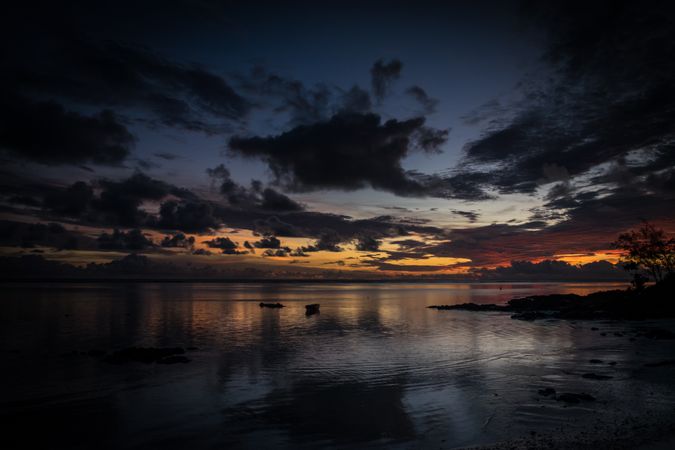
[229,114,447,196]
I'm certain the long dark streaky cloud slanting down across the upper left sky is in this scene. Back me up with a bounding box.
[2,34,250,133]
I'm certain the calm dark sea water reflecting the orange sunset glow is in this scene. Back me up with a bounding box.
[0,283,675,449]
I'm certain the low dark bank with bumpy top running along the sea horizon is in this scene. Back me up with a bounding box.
[0,253,629,283]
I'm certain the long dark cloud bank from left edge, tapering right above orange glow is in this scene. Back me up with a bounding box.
[0,173,440,247]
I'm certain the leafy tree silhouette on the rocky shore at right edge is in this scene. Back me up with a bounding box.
[612,221,675,289]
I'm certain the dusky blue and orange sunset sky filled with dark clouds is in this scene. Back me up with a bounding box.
[0,0,675,279]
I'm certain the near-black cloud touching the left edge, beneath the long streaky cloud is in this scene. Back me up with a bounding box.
[0,92,135,165]
